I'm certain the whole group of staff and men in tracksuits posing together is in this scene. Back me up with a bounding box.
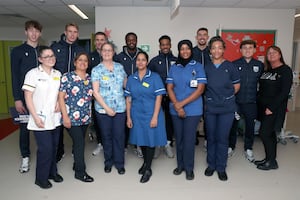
[11,20,292,188]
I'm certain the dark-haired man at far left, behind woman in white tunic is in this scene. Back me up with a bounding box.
[10,20,42,173]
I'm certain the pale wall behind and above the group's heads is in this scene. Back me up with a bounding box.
[95,7,295,64]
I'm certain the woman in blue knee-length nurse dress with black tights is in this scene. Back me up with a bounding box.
[125,52,167,183]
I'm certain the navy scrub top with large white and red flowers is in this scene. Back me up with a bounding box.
[59,71,93,126]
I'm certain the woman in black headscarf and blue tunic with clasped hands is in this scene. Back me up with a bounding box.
[166,40,206,180]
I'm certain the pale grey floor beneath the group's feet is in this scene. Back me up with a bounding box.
[0,111,300,200]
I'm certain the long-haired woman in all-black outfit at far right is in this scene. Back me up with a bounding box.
[254,46,293,170]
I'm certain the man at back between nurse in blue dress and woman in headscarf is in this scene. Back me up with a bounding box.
[148,35,177,158]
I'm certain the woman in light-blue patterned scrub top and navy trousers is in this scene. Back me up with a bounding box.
[92,43,127,175]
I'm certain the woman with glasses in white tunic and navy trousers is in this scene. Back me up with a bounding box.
[22,46,63,189]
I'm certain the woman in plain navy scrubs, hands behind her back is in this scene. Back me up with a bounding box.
[204,36,240,181]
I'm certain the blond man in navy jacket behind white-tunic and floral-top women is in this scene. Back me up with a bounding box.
[51,23,85,162]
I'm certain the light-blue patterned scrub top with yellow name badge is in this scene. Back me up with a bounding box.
[92,62,127,114]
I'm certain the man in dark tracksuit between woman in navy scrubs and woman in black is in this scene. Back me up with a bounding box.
[228,40,264,162]
